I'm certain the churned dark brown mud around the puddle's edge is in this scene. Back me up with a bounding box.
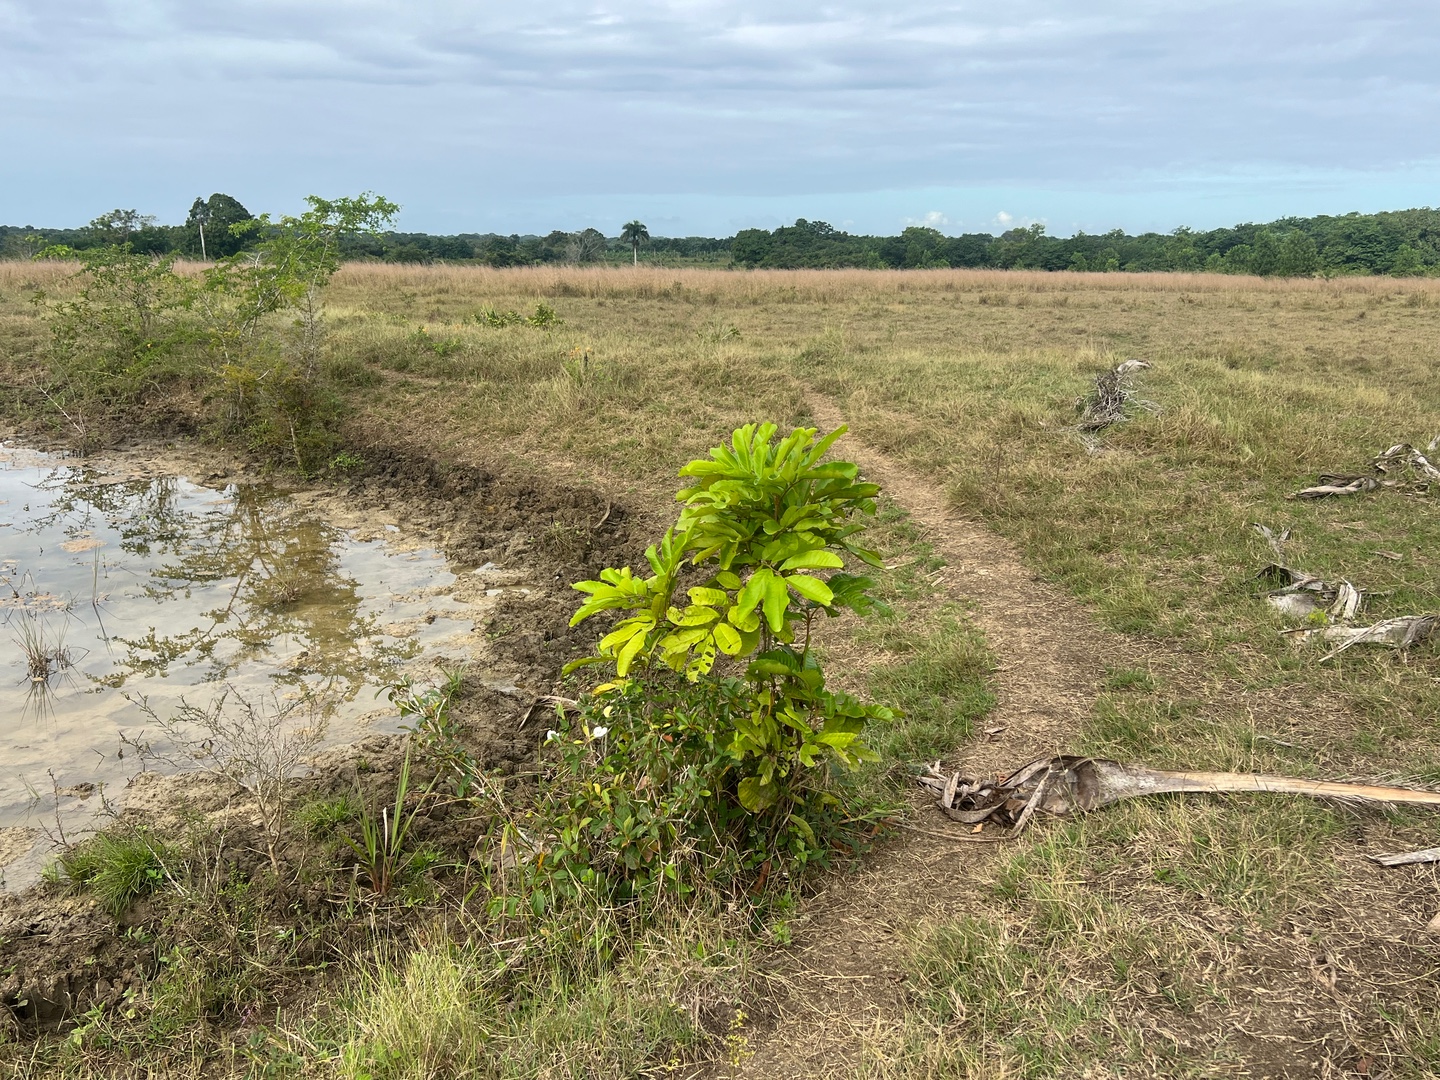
[0,432,635,1032]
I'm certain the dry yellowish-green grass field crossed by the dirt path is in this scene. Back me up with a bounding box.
[0,264,1440,1080]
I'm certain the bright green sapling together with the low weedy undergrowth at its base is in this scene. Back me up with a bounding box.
[535,423,894,893]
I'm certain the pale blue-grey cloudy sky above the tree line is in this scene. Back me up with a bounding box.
[0,0,1440,236]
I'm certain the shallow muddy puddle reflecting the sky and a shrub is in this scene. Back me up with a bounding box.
[0,445,526,888]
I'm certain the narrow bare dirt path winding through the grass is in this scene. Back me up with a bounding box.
[733,402,1129,1080]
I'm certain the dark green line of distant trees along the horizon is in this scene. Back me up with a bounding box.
[0,194,1440,276]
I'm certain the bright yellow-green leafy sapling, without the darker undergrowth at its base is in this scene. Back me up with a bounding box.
[567,423,894,817]
